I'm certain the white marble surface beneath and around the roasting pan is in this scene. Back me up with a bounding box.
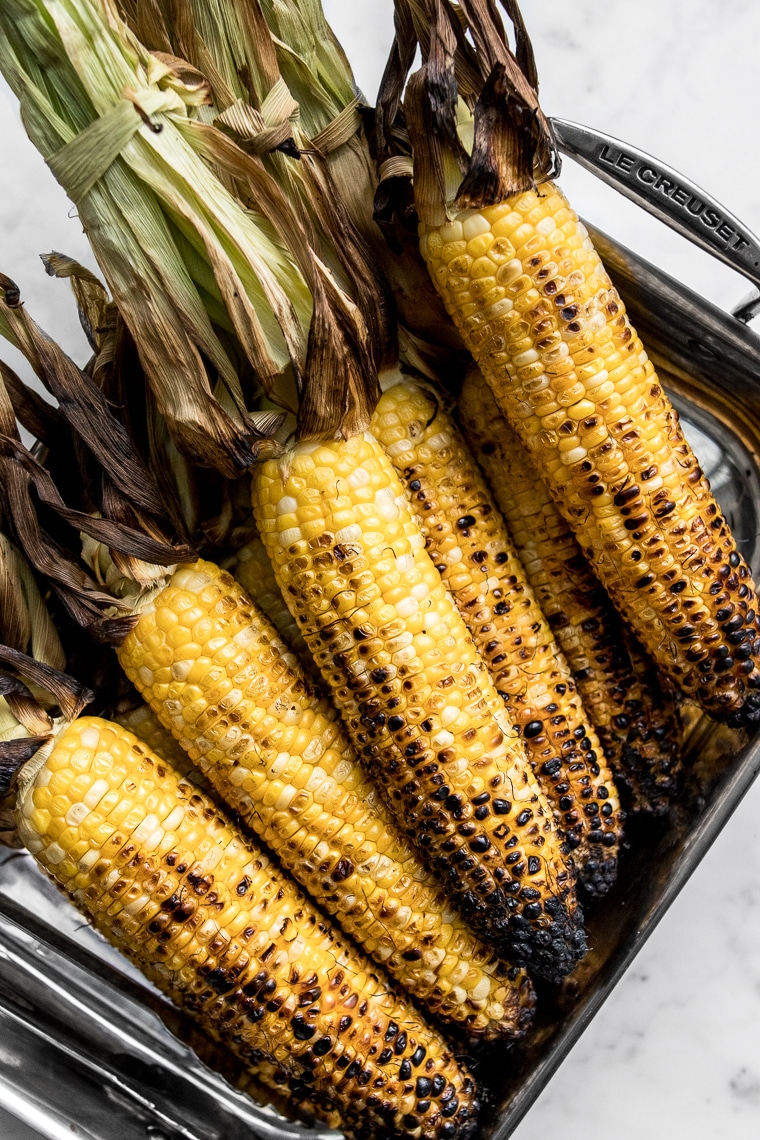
[0,0,760,1140]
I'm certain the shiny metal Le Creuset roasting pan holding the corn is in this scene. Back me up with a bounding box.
[0,121,760,1140]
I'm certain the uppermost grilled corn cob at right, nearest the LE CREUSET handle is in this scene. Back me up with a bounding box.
[420,182,760,723]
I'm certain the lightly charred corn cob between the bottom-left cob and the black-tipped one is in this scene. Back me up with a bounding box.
[117,562,534,1039]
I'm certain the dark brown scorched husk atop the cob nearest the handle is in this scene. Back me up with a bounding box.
[378,0,558,225]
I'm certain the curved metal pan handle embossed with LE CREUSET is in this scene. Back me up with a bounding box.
[551,119,760,319]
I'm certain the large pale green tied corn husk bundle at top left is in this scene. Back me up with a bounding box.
[0,0,321,474]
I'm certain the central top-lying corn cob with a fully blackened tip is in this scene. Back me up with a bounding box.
[252,433,583,976]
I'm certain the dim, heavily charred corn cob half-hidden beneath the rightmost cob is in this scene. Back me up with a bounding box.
[458,368,681,813]
